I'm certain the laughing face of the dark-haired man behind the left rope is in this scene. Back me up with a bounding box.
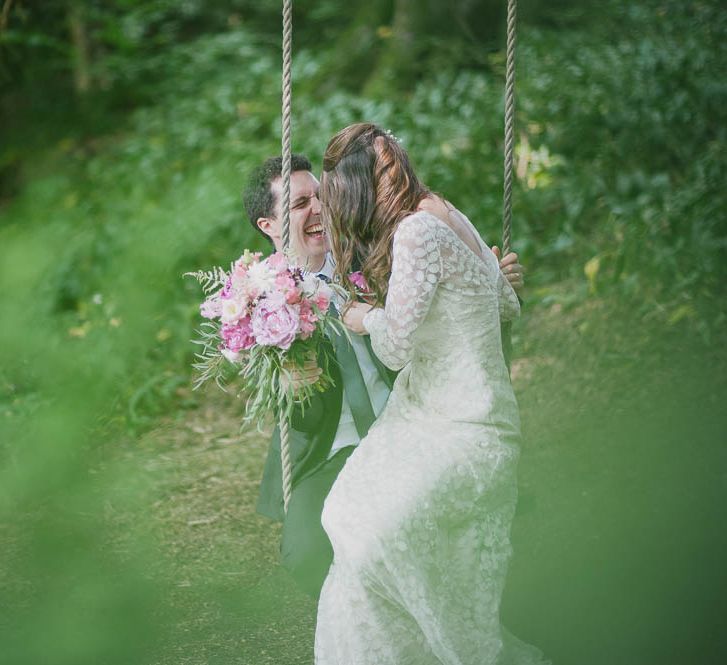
[258,171,328,265]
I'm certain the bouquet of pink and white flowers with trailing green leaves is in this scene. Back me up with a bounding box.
[186,250,345,422]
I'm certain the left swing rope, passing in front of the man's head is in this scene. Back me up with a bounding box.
[279,0,293,512]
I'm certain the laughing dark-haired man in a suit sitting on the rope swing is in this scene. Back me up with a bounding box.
[243,155,523,598]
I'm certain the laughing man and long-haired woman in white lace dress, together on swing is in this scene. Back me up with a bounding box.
[244,123,546,665]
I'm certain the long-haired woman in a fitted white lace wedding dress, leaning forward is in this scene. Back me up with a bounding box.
[315,123,546,665]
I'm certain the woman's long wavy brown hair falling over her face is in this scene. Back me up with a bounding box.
[320,123,429,305]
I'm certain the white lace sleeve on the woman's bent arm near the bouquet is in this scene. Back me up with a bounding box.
[363,215,442,370]
